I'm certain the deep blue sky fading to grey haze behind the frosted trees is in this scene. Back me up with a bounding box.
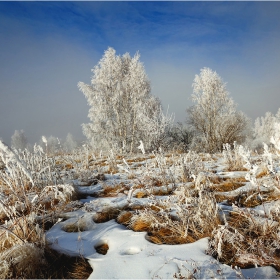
[0,1,280,143]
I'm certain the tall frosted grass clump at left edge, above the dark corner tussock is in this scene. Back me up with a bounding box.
[0,141,74,231]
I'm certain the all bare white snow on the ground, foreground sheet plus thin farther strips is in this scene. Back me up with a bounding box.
[46,151,278,279]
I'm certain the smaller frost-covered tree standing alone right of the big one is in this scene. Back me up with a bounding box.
[187,68,249,153]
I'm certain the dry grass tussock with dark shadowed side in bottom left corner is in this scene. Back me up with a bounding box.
[0,243,93,279]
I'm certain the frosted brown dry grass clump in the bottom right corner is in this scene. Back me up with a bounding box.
[208,210,280,271]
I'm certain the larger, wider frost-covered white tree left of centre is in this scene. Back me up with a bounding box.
[78,48,172,152]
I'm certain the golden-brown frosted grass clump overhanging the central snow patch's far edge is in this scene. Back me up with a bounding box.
[125,188,220,244]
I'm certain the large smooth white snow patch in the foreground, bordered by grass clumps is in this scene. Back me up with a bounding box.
[46,198,277,279]
